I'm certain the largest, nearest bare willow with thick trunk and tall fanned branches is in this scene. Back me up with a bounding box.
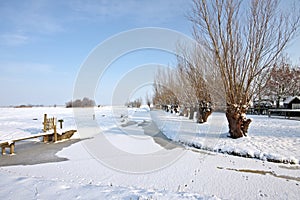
[190,0,299,138]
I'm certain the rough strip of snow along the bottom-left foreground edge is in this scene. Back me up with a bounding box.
[0,171,214,200]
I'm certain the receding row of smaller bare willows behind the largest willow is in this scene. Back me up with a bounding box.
[153,45,217,123]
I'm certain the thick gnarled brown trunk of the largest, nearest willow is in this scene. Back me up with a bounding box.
[226,104,252,138]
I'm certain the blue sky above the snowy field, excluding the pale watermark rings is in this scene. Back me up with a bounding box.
[0,0,300,106]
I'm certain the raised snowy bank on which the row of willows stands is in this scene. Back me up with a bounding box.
[151,111,300,164]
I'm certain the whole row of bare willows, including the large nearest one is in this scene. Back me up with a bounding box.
[154,0,300,138]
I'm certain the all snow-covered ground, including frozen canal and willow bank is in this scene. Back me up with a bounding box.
[0,107,300,199]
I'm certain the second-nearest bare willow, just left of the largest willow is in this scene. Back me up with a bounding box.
[177,46,212,123]
